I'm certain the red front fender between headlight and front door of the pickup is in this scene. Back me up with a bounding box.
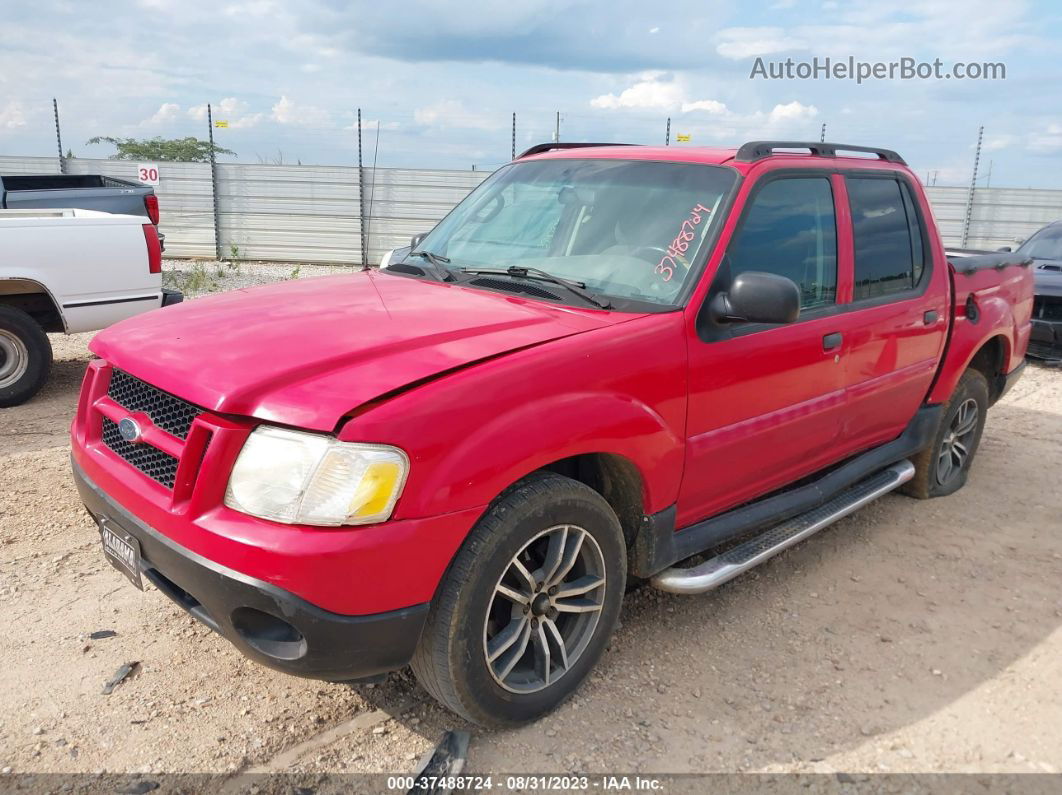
[339,312,687,519]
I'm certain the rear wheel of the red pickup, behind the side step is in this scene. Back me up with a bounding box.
[902,369,989,500]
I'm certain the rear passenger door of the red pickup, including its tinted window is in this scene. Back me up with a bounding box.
[842,171,948,452]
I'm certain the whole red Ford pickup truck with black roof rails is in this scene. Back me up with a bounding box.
[72,141,1032,725]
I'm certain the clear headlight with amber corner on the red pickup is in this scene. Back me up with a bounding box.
[225,426,409,526]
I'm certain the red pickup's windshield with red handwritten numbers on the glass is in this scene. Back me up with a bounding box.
[409,159,735,305]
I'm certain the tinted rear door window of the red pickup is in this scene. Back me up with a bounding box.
[847,177,924,300]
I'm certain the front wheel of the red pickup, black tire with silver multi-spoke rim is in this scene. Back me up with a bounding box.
[412,473,627,727]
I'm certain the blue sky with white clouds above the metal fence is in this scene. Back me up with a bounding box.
[0,0,1062,188]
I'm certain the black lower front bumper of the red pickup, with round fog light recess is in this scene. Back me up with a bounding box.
[73,462,428,681]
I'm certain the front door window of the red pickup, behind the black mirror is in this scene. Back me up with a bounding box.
[726,177,837,308]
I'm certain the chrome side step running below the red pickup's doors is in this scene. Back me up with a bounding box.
[650,461,914,593]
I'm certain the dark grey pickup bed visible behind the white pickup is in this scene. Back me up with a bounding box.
[0,174,158,226]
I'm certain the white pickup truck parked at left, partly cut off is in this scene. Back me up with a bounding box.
[0,209,182,408]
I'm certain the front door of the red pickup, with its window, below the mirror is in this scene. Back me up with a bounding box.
[678,169,847,526]
